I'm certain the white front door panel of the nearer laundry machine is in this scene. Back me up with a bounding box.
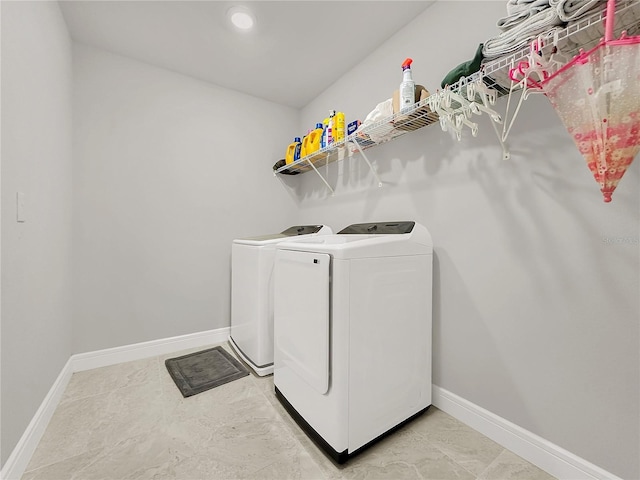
[274,249,331,394]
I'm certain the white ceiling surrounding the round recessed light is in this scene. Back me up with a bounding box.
[60,0,433,108]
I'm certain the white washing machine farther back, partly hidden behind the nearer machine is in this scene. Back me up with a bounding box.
[229,225,333,376]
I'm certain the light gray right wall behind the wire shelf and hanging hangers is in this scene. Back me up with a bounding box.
[287,1,640,478]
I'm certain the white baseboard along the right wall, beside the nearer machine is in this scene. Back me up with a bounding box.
[432,385,621,480]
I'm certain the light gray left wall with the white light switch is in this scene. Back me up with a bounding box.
[0,1,72,464]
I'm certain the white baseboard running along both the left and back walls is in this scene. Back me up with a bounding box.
[0,327,230,480]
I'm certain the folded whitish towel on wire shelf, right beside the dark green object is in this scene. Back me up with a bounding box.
[482,8,563,59]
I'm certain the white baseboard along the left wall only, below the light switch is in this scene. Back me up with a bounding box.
[0,358,73,480]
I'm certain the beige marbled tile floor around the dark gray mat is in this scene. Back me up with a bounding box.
[22,344,553,480]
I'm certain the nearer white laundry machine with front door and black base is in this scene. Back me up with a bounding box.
[274,222,433,463]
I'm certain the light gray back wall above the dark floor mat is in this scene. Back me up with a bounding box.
[73,44,298,353]
